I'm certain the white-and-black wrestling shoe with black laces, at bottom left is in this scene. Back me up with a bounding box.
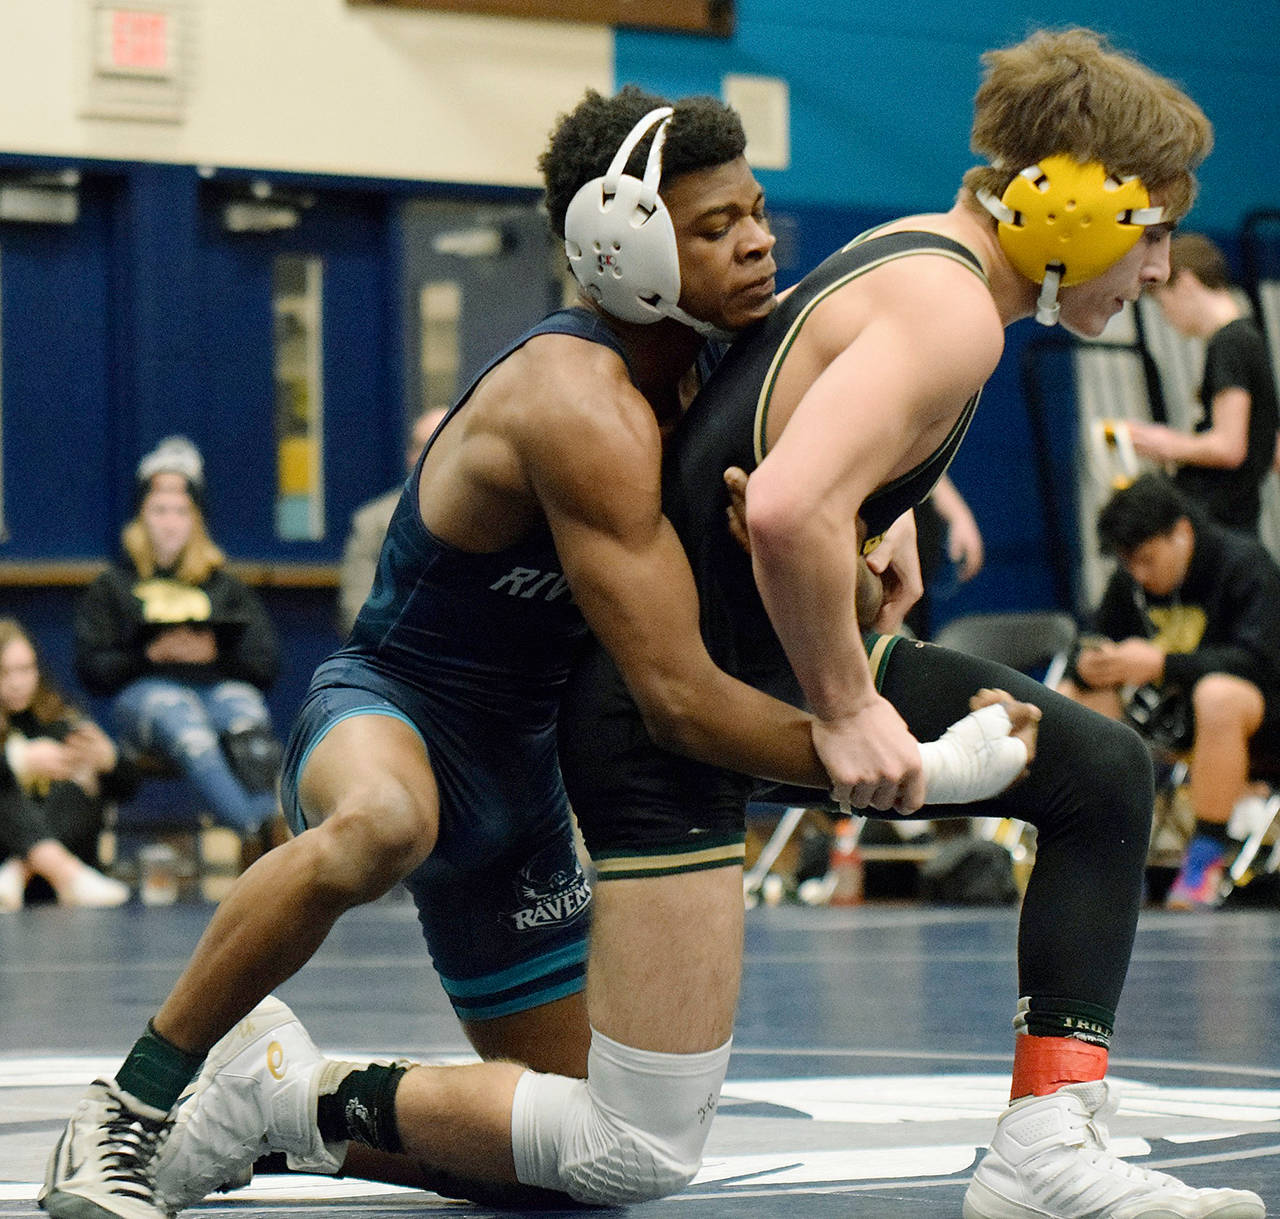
[36,1079,173,1219]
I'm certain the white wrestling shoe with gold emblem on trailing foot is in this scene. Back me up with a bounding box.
[156,996,351,1211]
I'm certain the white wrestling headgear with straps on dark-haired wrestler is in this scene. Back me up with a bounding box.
[564,106,721,335]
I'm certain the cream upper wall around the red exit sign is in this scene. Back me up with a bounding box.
[0,0,613,186]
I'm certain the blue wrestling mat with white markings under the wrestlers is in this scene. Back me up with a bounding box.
[0,899,1280,1219]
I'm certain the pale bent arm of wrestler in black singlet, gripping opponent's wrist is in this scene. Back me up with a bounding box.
[746,256,1002,812]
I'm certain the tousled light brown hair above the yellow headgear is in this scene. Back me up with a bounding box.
[964,28,1213,222]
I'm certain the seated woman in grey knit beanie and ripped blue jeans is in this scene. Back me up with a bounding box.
[76,437,280,837]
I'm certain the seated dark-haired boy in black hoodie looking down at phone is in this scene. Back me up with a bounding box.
[1064,474,1280,909]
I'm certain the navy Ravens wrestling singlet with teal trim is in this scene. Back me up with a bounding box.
[282,309,625,1019]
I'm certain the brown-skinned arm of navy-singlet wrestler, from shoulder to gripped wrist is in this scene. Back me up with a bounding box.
[518,344,838,787]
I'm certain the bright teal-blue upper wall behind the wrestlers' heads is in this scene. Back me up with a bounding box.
[614,0,1280,229]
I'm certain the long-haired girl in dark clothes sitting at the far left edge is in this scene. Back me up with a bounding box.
[0,618,132,910]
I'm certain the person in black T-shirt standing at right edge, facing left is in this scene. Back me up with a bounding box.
[1130,233,1280,534]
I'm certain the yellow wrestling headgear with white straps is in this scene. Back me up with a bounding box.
[977,154,1165,327]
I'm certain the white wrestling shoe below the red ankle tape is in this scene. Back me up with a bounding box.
[964,1079,1266,1219]
